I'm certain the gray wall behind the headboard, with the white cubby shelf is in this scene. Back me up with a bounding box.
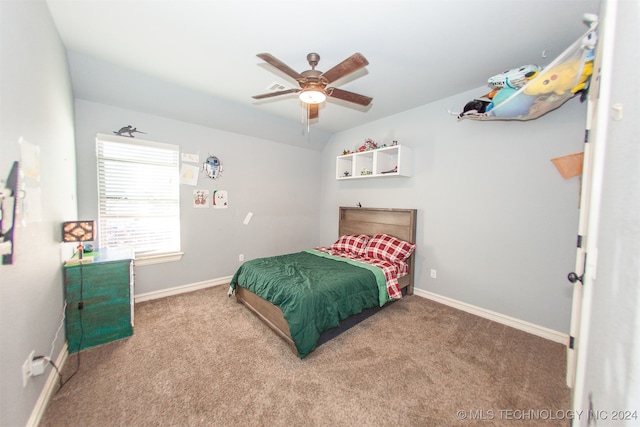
[321,88,586,333]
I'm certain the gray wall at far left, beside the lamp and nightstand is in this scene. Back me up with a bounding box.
[0,0,76,426]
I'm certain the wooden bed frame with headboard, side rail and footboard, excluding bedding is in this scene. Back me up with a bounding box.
[236,207,417,355]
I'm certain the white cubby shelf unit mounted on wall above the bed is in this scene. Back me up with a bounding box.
[336,145,413,181]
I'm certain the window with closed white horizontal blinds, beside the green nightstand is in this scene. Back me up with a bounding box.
[96,134,180,264]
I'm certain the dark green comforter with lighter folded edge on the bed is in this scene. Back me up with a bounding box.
[230,250,388,358]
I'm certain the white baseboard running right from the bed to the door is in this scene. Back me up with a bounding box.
[413,288,569,345]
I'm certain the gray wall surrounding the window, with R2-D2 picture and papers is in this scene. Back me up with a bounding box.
[76,100,320,295]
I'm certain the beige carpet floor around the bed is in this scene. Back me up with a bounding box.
[41,286,570,426]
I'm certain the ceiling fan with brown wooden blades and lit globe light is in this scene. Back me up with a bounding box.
[253,52,373,119]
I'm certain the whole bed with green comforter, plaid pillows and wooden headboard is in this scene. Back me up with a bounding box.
[230,207,417,358]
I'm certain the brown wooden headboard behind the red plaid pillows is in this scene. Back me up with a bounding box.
[338,207,418,295]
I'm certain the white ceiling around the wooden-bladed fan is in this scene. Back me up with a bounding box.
[46,0,600,139]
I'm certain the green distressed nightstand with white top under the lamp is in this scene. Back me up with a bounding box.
[64,248,134,354]
